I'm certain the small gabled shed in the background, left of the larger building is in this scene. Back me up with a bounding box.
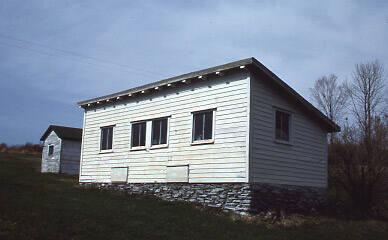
[40,125,82,175]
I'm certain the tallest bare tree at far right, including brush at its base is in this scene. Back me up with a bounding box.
[333,61,388,216]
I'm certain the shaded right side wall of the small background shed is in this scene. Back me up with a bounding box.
[61,140,81,174]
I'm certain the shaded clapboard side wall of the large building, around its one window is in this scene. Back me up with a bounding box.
[249,76,327,187]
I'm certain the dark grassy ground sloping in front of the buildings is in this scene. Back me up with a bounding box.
[0,153,388,240]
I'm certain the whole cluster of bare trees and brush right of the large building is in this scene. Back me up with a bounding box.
[311,60,388,216]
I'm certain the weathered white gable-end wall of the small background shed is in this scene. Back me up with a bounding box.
[41,132,61,173]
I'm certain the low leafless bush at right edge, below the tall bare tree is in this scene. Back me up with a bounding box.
[329,118,388,215]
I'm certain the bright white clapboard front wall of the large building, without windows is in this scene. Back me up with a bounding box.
[80,70,249,183]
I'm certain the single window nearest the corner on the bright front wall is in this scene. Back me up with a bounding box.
[193,110,213,142]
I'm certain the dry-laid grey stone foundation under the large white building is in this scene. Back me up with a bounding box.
[80,183,326,215]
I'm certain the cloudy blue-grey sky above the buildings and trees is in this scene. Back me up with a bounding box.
[0,0,388,144]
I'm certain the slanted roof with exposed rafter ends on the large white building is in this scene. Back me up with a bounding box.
[78,57,341,132]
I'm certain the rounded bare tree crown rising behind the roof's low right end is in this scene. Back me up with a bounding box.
[310,74,348,143]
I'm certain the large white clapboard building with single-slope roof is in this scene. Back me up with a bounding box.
[79,58,339,214]
